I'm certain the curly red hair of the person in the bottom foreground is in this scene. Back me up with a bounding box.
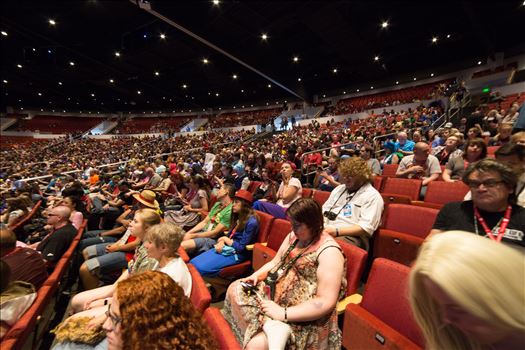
[116,271,216,350]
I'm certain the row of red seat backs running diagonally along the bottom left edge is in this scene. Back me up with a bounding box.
[0,220,87,350]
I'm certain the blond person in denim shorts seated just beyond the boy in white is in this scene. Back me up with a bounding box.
[80,209,160,289]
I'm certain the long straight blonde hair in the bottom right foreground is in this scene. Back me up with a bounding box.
[409,231,525,350]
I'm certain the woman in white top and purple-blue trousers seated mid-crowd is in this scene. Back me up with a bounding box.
[253,163,303,219]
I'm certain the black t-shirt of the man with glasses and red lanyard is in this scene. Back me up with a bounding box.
[432,201,525,247]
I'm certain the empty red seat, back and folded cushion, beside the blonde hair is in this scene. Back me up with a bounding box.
[343,259,424,350]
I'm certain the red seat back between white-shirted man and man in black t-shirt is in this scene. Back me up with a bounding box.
[383,204,439,238]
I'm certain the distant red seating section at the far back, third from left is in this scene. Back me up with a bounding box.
[208,108,282,129]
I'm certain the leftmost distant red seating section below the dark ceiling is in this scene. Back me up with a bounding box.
[8,115,104,134]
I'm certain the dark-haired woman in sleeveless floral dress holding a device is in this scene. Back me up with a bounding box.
[223,198,346,349]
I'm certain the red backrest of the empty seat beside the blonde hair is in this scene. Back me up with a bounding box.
[360,258,424,346]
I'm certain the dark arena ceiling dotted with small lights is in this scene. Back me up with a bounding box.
[0,0,525,112]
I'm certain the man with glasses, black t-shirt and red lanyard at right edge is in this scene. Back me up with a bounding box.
[430,159,525,248]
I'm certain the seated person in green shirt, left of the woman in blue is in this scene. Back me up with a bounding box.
[181,183,235,254]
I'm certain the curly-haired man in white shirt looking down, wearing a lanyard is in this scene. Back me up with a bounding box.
[323,157,384,250]
